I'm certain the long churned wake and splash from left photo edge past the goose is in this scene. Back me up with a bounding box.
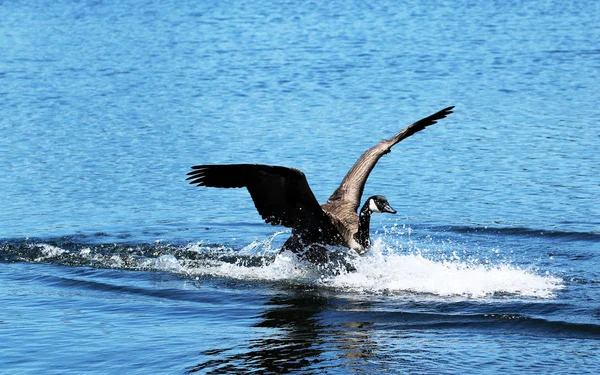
[0,234,563,299]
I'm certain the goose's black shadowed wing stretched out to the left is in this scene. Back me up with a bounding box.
[187,164,327,228]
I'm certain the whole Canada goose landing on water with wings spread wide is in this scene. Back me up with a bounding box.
[187,106,454,262]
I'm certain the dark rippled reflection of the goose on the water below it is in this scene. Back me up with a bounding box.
[187,288,377,374]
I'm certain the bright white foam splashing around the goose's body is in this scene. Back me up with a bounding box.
[186,239,563,298]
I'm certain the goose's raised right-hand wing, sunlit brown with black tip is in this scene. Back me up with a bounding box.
[325,106,454,213]
